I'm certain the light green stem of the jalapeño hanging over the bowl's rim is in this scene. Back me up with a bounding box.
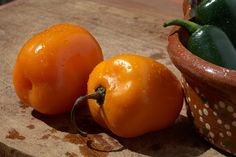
[163,19,201,34]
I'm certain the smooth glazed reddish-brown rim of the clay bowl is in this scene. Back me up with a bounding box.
[167,26,236,89]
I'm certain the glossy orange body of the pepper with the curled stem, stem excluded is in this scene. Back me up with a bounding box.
[85,54,183,137]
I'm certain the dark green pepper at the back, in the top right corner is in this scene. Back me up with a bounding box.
[195,0,236,48]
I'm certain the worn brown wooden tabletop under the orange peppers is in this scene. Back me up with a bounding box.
[0,0,229,157]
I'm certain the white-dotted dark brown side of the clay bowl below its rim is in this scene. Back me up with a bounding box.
[185,83,236,155]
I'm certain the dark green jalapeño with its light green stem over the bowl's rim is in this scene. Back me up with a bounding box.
[164,19,236,70]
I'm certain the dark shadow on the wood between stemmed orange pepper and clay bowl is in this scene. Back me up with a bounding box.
[115,116,211,157]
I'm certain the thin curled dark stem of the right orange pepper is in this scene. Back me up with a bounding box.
[70,86,106,136]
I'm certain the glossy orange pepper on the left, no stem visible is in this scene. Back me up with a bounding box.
[13,24,103,114]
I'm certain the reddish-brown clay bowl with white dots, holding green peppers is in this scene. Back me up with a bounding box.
[168,27,236,155]
